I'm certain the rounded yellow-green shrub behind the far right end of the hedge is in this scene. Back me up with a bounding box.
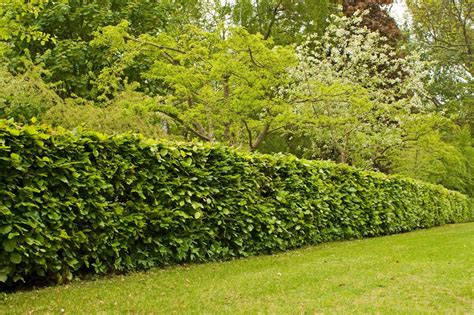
[391,114,474,196]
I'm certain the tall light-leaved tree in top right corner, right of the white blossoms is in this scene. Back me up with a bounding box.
[407,0,474,132]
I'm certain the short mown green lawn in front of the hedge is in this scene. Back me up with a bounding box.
[0,223,474,314]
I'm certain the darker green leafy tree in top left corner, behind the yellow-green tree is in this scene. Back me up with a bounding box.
[0,0,206,99]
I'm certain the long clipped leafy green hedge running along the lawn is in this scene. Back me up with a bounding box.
[0,121,472,286]
